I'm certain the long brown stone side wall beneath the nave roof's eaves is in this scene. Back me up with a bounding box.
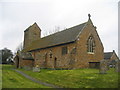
[32,43,76,68]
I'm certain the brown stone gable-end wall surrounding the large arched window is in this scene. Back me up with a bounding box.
[75,21,104,68]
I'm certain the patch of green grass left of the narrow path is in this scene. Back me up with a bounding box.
[2,65,48,88]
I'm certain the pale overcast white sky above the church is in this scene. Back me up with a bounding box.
[0,0,119,55]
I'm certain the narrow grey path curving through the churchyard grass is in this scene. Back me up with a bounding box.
[13,69,60,88]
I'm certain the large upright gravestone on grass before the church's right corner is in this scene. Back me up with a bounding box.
[99,60,108,74]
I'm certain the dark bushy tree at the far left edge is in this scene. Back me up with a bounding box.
[0,48,13,64]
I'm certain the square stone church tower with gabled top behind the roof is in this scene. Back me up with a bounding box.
[23,22,41,48]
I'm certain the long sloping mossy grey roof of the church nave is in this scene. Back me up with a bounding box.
[24,22,86,51]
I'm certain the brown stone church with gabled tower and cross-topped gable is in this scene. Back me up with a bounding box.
[16,14,104,69]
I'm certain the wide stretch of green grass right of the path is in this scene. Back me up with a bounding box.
[19,69,118,88]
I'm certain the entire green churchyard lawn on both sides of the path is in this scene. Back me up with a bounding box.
[2,65,118,88]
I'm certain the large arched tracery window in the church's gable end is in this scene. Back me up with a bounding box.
[87,36,95,53]
